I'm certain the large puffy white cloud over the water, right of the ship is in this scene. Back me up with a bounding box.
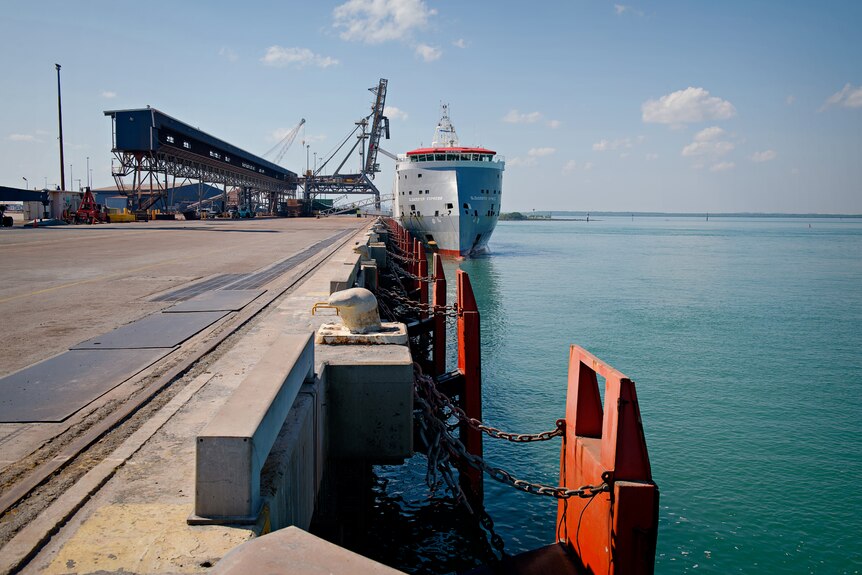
[641,87,736,126]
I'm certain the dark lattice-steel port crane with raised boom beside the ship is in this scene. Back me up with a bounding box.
[298,78,389,216]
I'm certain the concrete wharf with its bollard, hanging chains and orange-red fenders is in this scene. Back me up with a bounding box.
[0,217,659,575]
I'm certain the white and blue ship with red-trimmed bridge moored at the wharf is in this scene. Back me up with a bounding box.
[393,104,505,257]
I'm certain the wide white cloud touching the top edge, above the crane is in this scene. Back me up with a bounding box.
[332,0,437,44]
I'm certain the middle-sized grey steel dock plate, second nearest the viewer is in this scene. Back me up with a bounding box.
[71,311,229,349]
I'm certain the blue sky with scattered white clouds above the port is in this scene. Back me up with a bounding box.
[0,0,862,214]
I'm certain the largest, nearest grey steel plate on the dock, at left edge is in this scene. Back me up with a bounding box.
[0,348,173,423]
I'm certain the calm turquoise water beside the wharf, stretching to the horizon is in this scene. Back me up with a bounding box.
[365,218,862,574]
